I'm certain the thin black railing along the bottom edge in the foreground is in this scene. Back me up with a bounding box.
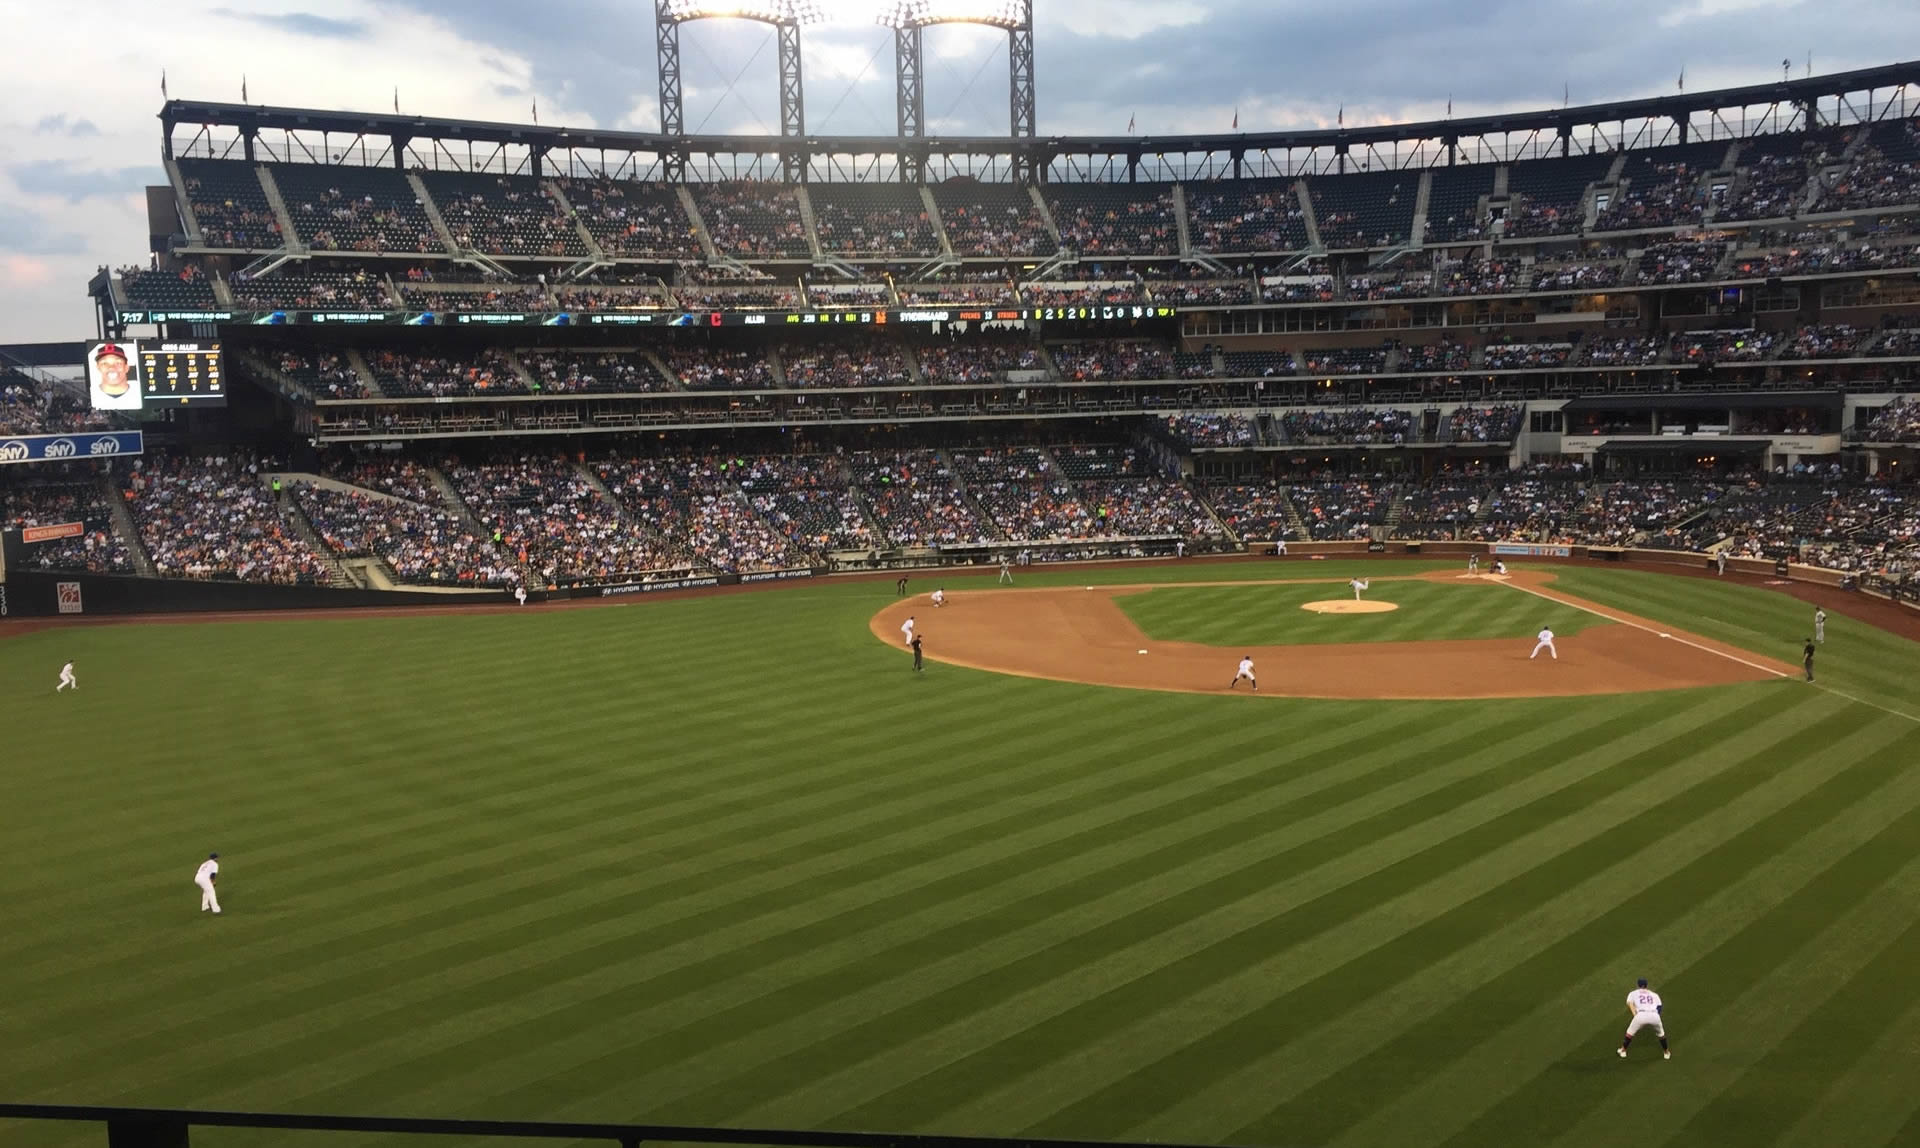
[0,1104,1228,1148]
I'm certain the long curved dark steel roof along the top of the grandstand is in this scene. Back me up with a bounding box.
[159,61,1920,170]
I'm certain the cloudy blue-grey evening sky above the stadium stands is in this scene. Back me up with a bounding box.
[0,0,1920,342]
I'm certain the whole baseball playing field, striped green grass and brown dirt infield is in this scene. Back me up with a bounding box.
[0,561,1920,1148]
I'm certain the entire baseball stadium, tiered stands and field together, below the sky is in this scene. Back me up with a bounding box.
[0,0,1920,1148]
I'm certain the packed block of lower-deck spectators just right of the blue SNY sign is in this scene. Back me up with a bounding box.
[129,455,330,586]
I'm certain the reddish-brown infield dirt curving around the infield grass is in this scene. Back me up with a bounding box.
[868,570,1799,701]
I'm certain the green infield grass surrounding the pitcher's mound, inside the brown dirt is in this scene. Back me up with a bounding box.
[1116,582,1605,645]
